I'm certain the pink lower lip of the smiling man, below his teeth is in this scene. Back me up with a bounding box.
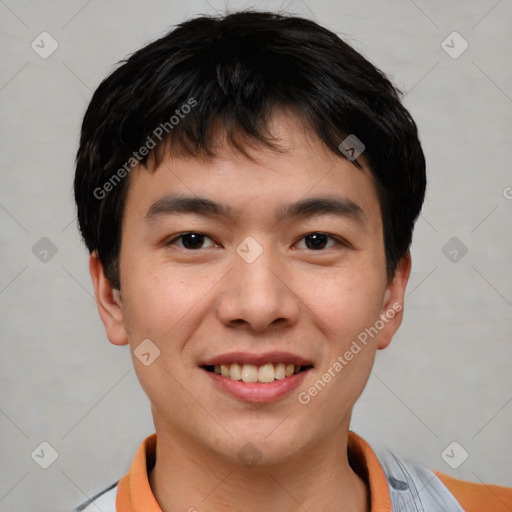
[203,369,310,403]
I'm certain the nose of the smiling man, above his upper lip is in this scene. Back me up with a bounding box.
[217,246,301,332]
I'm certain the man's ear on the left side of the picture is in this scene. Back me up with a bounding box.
[89,251,128,345]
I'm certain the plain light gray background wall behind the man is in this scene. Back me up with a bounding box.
[0,0,512,512]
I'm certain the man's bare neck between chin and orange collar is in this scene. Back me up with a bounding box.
[149,426,370,512]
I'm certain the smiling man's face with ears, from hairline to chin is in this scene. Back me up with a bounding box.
[91,113,410,463]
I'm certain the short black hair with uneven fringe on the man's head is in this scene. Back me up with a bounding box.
[74,10,426,289]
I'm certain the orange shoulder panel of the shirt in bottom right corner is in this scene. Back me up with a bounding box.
[434,471,512,512]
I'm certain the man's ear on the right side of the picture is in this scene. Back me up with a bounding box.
[377,251,411,350]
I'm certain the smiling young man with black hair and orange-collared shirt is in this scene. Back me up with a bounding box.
[75,12,512,512]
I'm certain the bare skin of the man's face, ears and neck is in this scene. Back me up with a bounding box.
[90,112,411,512]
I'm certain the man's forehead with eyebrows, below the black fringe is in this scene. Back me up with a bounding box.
[125,113,380,232]
